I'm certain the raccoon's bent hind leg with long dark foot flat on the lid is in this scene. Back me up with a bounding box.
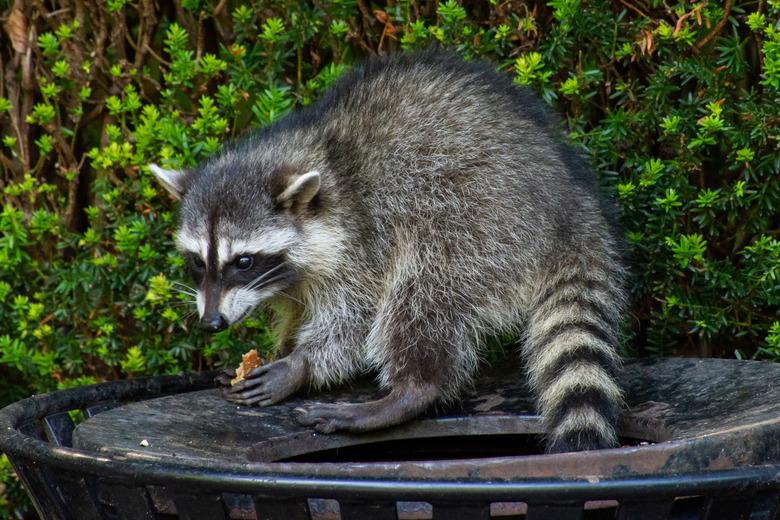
[298,279,476,433]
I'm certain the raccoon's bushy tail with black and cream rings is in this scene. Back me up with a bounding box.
[523,258,624,453]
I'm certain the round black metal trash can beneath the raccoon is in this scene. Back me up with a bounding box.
[0,359,780,520]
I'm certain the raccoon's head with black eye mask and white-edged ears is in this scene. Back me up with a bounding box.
[149,161,320,332]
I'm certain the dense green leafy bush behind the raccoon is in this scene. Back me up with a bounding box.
[0,0,780,517]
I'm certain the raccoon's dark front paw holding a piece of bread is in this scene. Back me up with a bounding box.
[224,357,306,406]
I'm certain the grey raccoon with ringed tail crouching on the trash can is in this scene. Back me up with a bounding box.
[150,51,626,452]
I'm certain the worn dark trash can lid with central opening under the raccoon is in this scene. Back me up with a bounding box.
[73,359,780,479]
